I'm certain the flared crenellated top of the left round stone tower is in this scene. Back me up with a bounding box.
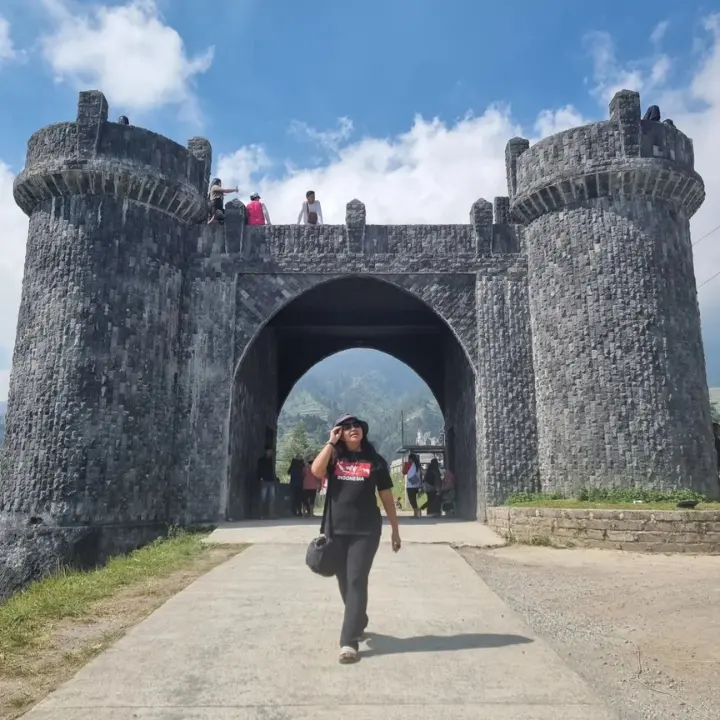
[14,90,212,222]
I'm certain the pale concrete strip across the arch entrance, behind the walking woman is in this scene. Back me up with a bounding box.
[202,514,505,547]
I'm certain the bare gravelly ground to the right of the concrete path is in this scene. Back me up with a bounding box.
[460,545,720,720]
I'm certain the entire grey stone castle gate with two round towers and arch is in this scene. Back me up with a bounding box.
[0,91,718,596]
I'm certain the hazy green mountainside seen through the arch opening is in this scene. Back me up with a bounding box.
[278,349,443,474]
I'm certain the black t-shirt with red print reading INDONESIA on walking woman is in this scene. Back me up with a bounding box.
[328,452,393,535]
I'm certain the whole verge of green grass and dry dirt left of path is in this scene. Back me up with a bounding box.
[0,532,244,720]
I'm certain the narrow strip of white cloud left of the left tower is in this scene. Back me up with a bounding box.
[0,161,28,400]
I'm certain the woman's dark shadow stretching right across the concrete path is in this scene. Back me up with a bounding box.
[362,633,533,658]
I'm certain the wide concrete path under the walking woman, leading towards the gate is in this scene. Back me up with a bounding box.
[26,534,614,720]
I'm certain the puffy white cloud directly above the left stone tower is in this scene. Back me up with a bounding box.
[42,0,214,122]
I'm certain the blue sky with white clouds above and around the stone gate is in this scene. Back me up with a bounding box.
[0,0,720,399]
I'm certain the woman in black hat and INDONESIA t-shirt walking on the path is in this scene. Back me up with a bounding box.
[312,415,400,663]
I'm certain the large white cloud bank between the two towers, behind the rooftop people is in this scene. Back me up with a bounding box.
[217,106,584,223]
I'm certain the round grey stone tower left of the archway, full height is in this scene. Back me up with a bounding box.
[0,91,212,593]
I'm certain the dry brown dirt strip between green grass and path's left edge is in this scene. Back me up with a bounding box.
[0,546,241,720]
